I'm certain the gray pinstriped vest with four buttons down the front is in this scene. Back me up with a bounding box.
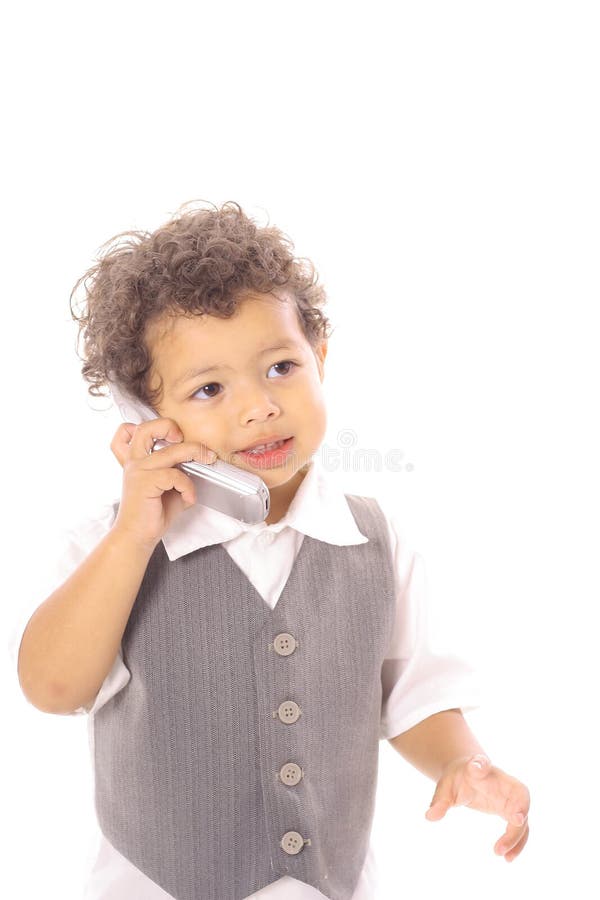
[94,495,395,900]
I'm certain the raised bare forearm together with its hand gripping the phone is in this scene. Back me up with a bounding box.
[17,418,220,715]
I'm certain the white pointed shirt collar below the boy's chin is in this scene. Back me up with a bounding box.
[162,456,368,561]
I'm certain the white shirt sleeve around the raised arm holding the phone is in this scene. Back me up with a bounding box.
[8,503,131,715]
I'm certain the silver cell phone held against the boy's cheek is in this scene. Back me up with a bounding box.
[109,382,269,525]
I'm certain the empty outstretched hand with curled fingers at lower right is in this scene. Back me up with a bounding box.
[425,753,530,862]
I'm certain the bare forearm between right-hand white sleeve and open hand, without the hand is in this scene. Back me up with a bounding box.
[390,709,485,781]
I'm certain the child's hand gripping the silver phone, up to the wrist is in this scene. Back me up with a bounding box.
[110,418,217,548]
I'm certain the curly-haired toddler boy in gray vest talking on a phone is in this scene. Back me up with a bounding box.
[15,203,529,900]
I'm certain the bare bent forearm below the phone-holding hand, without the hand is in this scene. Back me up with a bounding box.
[18,526,153,715]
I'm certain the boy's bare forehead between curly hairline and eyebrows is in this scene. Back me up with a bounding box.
[146,294,307,369]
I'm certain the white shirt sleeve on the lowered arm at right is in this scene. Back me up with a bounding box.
[379,504,481,740]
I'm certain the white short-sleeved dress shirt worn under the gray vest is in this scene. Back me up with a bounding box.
[10,455,480,900]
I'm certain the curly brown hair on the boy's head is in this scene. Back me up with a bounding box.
[69,201,331,406]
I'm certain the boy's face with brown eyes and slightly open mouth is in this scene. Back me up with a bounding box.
[146,293,327,523]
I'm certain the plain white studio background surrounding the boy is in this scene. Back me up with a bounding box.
[0,0,600,900]
